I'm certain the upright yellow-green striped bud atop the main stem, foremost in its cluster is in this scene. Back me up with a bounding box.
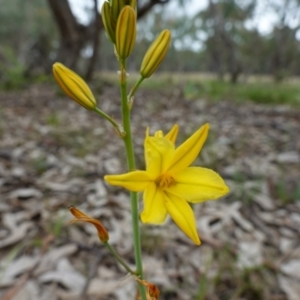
[116,5,136,59]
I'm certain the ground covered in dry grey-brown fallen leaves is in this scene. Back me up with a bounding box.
[0,80,300,300]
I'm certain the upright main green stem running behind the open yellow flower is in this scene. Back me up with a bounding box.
[120,63,147,300]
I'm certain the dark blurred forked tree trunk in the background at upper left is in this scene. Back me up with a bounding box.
[47,0,169,79]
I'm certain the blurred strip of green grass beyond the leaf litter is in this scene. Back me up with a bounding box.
[100,72,300,106]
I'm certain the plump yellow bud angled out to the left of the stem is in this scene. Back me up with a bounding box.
[53,63,97,110]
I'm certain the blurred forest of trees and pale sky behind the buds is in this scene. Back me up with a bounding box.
[0,0,300,89]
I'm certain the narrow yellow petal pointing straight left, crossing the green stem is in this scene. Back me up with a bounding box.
[104,171,152,192]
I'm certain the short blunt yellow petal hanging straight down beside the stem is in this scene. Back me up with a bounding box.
[141,183,167,224]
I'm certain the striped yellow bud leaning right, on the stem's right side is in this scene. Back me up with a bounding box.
[140,30,171,78]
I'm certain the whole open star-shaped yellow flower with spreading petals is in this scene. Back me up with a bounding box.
[104,124,229,245]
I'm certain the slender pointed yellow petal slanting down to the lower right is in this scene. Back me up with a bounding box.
[164,192,200,245]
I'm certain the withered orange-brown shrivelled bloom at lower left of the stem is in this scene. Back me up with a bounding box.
[69,206,109,243]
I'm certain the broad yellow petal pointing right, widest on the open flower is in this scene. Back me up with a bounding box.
[168,167,229,203]
